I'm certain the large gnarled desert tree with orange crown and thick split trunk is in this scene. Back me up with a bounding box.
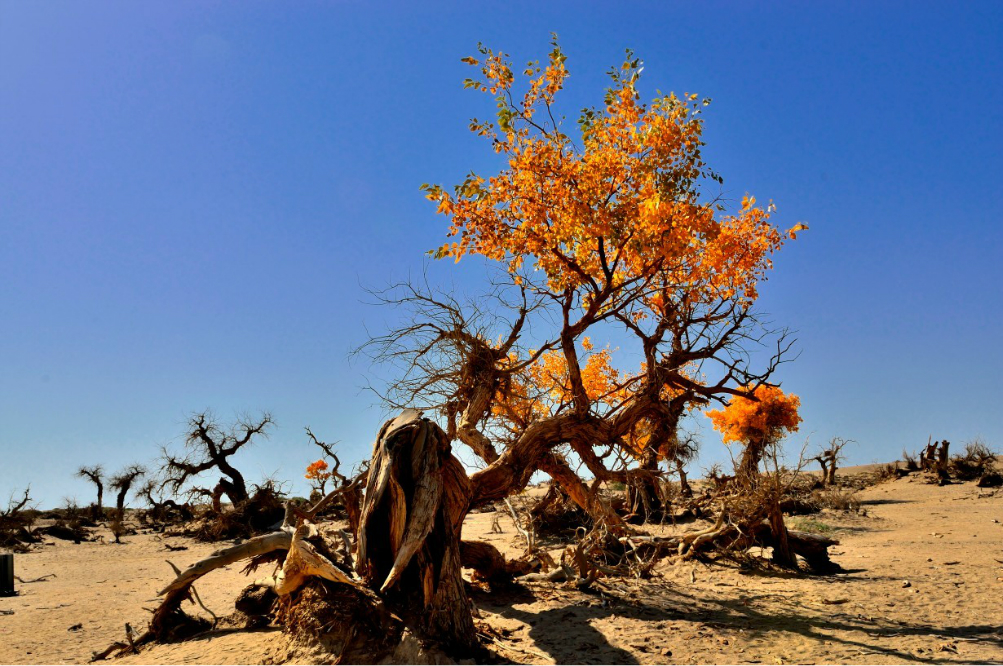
[148,44,796,653]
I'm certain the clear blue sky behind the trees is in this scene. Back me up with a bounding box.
[0,0,1003,506]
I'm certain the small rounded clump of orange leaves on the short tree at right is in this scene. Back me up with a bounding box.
[704,384,801,443]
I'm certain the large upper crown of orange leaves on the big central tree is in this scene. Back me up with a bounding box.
[423,42,793,318]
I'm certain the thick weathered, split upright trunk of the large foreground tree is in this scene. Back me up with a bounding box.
[356,409,477,654]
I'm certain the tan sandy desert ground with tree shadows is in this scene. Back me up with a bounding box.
[0,471,1003,664]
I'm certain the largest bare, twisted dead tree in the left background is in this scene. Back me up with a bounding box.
[162,411,273,513]
